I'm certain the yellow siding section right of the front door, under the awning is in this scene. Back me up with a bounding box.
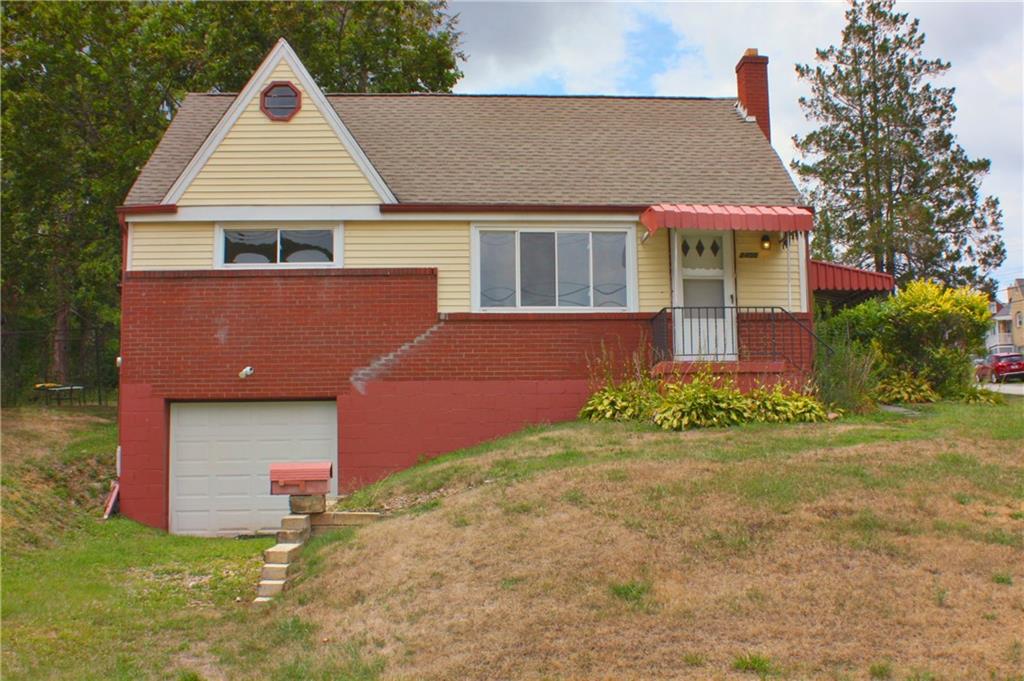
[735,231,804,312]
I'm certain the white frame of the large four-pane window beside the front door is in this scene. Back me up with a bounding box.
[470,222,639,314]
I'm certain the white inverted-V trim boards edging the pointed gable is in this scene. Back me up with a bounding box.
[160,38,398,205]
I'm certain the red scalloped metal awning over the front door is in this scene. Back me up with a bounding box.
[640,204,814,233]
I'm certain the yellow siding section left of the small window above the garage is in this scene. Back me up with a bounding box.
[129,222,214,269]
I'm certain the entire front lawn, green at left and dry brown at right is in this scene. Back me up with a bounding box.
[3,401,1024,679]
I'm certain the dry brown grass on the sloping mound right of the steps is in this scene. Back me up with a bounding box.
[190,406,1024,679]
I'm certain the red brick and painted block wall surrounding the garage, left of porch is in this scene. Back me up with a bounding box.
[120,269,651,527]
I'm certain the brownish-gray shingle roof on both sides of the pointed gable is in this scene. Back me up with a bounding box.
[126,94,800,206]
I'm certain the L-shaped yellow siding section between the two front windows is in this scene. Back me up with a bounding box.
[344,222,471,312]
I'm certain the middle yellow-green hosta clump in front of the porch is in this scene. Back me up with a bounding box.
[653,373,754,430]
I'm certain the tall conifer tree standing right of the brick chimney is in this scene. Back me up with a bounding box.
[793,0,1006,291]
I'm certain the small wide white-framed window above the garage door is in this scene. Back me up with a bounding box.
[219,226,340,267]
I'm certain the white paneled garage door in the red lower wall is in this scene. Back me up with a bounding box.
[170,401,338,535]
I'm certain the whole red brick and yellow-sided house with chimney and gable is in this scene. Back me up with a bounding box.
[119,41,888,535]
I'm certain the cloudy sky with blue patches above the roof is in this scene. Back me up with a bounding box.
[450,1,1024,299]
